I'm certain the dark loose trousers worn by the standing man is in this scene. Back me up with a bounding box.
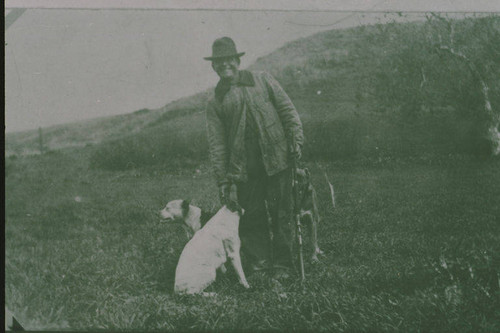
[237,169,294,268]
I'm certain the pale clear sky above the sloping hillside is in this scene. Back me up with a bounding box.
[5,0,500,132]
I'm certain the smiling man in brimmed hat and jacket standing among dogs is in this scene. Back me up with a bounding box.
[204,37,304,276]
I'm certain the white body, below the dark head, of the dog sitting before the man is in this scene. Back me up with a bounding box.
[174,201,250,294]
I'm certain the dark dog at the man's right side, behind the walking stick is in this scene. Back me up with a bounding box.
[296,168,323,261]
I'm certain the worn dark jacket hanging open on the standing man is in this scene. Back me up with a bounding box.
[206,71,304,185]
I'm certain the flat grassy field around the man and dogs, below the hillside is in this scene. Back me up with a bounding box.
[5,147,500,332]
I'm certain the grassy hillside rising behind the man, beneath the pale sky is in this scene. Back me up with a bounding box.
[6,17,500,162]
